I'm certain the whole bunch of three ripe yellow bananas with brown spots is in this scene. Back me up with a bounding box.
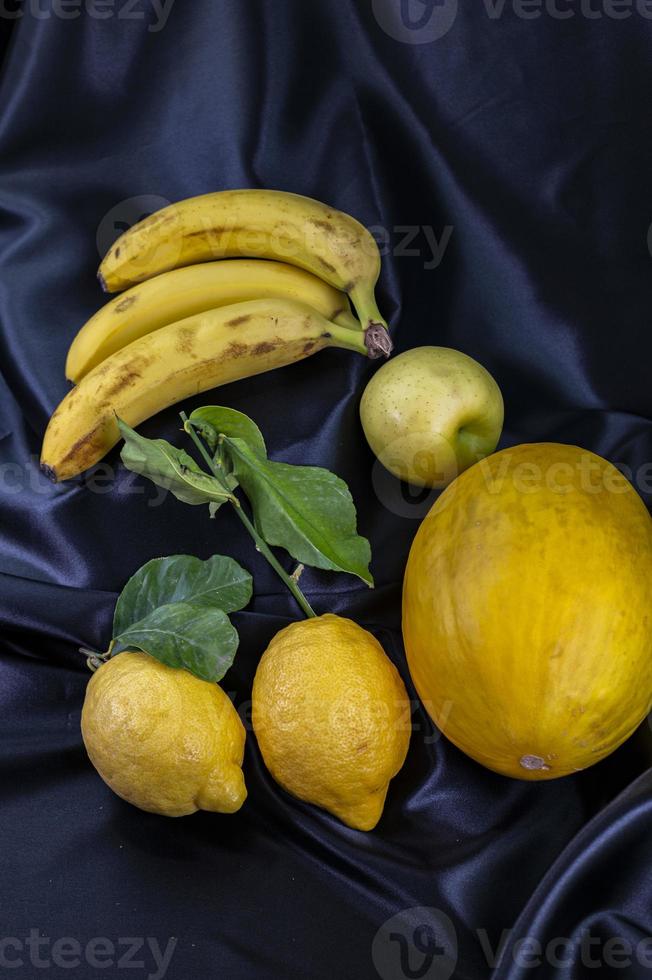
[41,190,392,481]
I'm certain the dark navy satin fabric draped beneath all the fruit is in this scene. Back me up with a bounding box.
[0,0,652,980]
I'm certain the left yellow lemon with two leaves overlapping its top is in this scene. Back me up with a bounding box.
[82,651,247,817]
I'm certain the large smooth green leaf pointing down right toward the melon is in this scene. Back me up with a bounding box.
[224,438,373,585]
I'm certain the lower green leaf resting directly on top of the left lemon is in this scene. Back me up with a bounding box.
[112,602,238,682]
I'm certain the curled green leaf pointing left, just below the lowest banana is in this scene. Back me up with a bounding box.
[118,419,237,506]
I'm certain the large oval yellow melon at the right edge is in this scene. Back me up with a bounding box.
[403,443,652,779]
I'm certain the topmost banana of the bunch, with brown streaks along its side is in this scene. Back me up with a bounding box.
[98,189,387,328]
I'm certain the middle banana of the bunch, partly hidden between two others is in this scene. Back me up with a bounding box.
[66,259,362,384]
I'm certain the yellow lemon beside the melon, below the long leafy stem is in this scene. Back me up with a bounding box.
[252,614,410,830]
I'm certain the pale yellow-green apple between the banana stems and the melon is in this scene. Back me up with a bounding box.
[360,347,504,487]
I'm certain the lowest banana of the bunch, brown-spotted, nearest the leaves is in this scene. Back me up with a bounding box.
[41,299,385,481]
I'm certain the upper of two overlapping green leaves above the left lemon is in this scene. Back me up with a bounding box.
[113,555,252,637]
